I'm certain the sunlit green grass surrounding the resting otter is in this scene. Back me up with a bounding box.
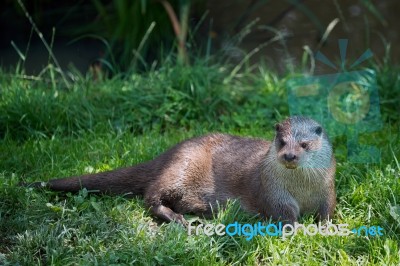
[0,59,400,265]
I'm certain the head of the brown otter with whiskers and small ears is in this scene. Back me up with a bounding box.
[274,116,332,169]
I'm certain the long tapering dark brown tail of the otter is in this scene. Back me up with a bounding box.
[27,161,155,195]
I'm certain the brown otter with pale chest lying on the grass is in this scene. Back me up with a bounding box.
[27,116,336,225]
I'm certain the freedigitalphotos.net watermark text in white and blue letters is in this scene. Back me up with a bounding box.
[187,222,383,241]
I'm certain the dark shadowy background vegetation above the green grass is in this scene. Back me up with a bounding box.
[0,0,400,73]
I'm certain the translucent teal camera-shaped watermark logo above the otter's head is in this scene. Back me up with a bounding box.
[286,39,382,163]
